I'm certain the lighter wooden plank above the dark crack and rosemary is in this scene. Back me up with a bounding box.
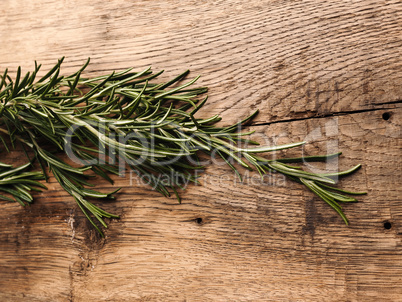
[0,1,402,123]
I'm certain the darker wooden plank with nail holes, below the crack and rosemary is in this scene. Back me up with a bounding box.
[1,109,402,301]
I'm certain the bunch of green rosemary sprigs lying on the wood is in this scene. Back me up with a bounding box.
[0,58,361,234]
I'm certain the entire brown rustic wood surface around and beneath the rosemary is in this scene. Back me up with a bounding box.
[0,0,402,301]
